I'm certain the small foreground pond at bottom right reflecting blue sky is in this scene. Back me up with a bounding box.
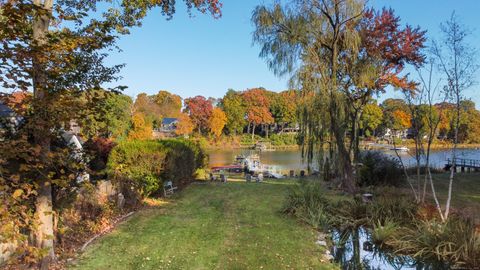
[331,227,449,270]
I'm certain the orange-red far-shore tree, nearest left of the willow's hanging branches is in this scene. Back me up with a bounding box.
[243,88,273,140]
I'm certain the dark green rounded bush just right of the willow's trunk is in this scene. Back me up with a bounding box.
[358,151,402,186]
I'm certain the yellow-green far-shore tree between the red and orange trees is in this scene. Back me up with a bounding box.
[219,89,247,134]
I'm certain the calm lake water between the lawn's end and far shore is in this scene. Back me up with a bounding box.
[209,149,480,170]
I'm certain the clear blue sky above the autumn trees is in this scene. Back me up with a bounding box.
[109,0,480,108]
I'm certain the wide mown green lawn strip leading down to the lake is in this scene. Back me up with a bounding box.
[71,180,337,269]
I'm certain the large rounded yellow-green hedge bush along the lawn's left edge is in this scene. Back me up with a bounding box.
[108,139,207,197]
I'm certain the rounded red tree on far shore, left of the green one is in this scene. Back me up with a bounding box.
[185,96,213,133]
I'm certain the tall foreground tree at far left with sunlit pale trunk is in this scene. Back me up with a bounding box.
[0,0,221,269]
